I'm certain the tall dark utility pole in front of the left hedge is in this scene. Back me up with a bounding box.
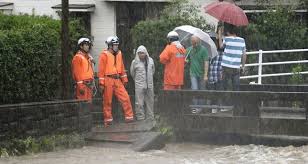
[61,0,70,99]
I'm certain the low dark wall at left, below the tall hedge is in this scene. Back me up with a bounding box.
[0,100,92,141]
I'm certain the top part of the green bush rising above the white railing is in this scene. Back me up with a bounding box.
[248,8,307,50]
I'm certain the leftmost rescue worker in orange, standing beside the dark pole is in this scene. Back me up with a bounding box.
[72,38,94,100]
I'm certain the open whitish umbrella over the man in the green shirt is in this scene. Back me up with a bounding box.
[174,25,218,58]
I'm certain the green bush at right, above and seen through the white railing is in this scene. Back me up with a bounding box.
[244,6,308,83]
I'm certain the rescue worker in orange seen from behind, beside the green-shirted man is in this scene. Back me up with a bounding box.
[159,31,186,90]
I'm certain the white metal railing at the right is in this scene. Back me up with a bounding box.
[240,49,308,84]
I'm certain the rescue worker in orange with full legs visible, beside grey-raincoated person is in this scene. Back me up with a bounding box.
[98,36,134,126]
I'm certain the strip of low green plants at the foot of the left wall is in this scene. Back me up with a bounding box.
[0,133,85,157]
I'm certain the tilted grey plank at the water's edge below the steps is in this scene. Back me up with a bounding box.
[132,132,165,152]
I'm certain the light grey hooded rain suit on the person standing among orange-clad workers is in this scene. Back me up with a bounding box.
[130,45,155,120]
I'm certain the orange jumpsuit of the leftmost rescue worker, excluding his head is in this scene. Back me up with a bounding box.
[72,51,94,100]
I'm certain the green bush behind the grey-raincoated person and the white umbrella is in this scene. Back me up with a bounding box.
[131,0,211,90]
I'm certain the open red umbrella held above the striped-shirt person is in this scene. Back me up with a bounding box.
[204,2,248,26]
